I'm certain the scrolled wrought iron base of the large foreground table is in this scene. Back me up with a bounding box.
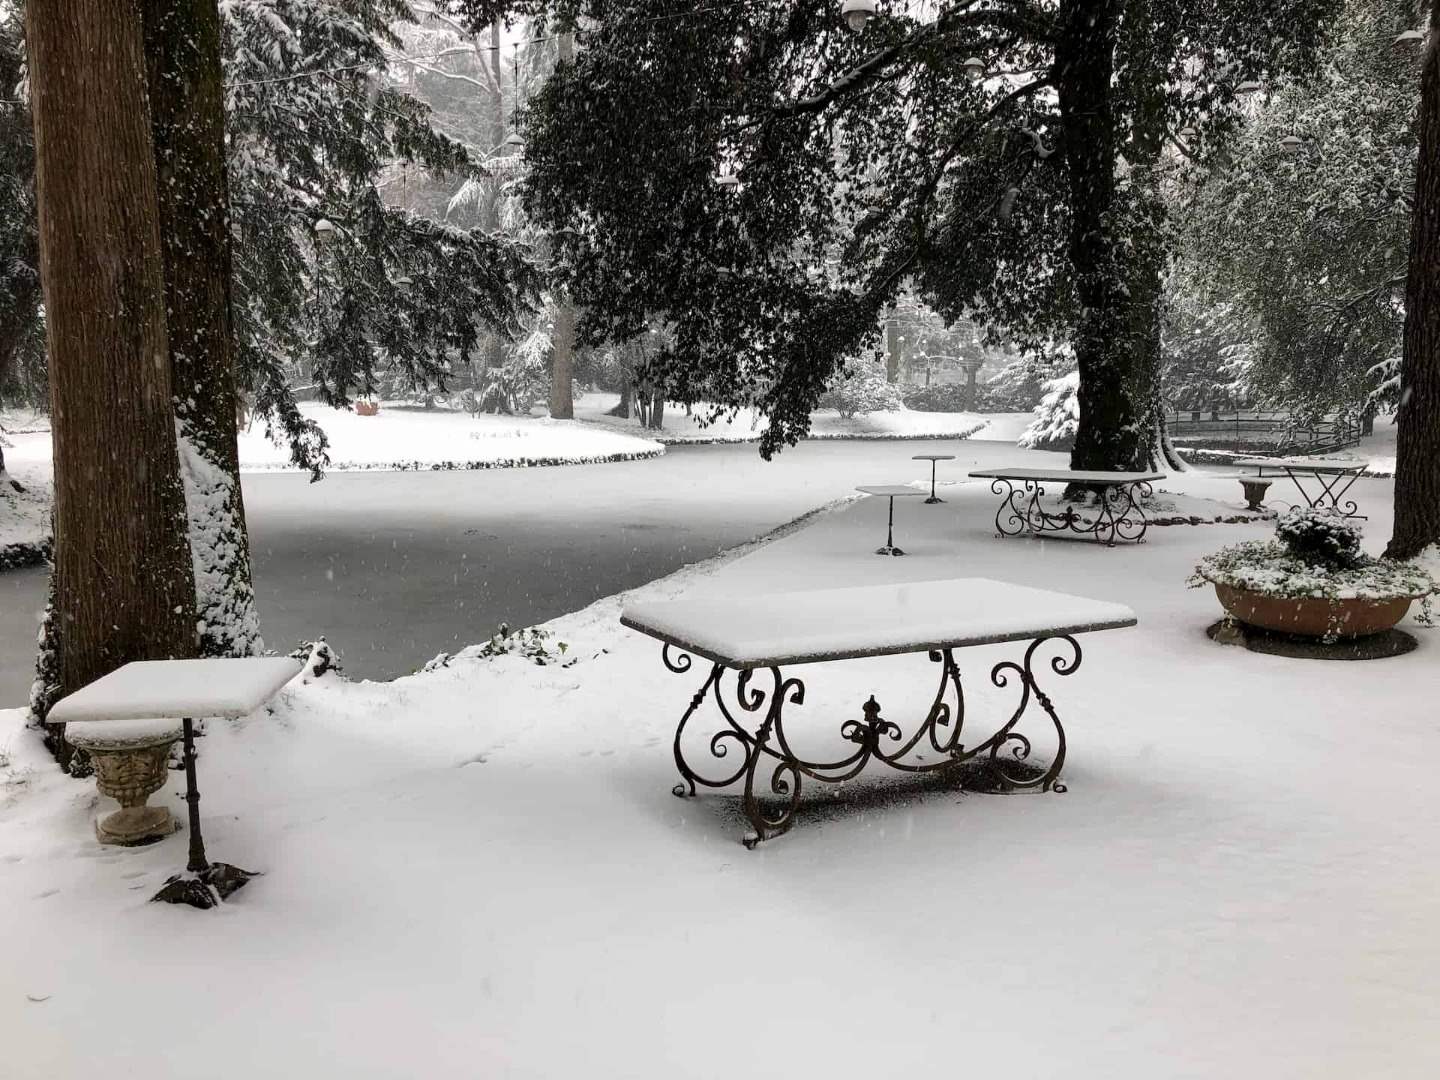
[662,635,1080,848]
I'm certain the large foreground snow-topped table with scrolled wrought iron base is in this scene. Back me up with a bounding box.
[621,577,1136,848]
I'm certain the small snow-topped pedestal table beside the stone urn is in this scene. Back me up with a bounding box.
[45,657,304,907]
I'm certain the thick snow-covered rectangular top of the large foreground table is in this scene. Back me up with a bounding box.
[621,577,1136,670]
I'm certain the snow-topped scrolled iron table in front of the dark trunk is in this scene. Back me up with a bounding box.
[971,468,1165,547]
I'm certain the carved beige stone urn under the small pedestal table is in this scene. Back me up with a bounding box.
[65,720,183,845]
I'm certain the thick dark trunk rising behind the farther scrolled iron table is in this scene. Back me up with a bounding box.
[1054,0,1148,469]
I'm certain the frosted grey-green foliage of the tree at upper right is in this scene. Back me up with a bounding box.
[1184,0,1421,419]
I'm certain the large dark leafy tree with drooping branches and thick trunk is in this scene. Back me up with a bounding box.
[451,0,1329,468]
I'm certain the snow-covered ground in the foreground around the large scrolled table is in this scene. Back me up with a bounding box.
[0,478,1440,1080]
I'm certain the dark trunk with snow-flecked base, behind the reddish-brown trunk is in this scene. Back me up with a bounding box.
[140,0,265,657]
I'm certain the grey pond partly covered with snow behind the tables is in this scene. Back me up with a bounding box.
[0,439,1060,707]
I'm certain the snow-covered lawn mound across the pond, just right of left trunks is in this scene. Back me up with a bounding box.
[240,403,665,472]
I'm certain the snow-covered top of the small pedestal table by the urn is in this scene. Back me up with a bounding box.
[46,657,304,724]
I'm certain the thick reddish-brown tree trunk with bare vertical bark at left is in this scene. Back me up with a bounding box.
[26,0,196,753]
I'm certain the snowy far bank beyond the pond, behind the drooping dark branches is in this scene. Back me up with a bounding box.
[575,393,989,444]
